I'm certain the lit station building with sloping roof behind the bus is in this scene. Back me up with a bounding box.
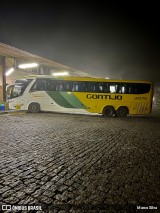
[0,42,90,103]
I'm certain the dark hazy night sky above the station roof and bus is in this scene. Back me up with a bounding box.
[0,0,160,82]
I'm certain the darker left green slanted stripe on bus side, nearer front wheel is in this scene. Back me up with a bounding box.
[47,91,75,108]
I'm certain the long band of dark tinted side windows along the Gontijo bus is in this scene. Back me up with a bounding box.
[31,79,151,94]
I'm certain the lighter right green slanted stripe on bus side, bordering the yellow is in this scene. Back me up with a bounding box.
[60,92,86,109]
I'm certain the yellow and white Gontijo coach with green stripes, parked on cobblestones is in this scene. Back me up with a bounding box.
[7,75,153,117]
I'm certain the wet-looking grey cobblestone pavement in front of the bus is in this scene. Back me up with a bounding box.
[0,113,160,213]
